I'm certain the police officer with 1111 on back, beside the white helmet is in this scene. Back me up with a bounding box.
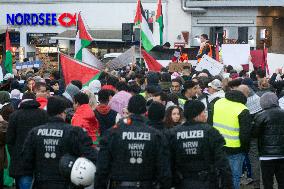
[20,97,97,189]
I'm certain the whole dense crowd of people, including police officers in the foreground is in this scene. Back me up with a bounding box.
[0,59,284,189]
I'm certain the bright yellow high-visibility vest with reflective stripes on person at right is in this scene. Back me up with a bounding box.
[213,98,247,148]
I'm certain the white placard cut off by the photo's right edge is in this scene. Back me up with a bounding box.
[267,53,284,75]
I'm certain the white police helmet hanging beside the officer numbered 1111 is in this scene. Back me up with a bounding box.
[70,157,96,186]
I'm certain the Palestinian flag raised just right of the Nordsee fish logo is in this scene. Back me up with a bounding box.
[75,13,93,61]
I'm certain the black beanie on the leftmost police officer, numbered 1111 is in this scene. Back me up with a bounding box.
[47,96,67,116]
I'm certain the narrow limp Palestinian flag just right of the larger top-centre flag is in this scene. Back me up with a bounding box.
[154,0,164,45]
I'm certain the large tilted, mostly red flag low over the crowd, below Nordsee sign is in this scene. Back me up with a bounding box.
[60,53,101,86]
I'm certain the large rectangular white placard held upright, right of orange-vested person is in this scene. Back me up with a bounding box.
[222,44,250,67]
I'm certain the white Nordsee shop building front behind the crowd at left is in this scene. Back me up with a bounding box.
[0,0,173,58]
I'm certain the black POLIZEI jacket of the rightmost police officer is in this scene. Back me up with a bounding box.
[166,120,233,189]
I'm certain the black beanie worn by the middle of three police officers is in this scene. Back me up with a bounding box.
[127,95,147,114]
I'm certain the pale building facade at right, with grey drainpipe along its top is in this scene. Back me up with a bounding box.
[182,0,284,53]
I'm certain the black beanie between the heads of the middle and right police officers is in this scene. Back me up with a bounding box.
[148,102,166,121]
